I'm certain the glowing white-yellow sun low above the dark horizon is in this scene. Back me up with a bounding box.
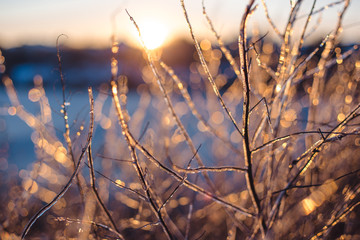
[139,20,168,50]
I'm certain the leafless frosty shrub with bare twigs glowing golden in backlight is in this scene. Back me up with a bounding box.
[1,0,360,239]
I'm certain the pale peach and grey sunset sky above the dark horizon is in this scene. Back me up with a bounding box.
[0,0,360,48]
